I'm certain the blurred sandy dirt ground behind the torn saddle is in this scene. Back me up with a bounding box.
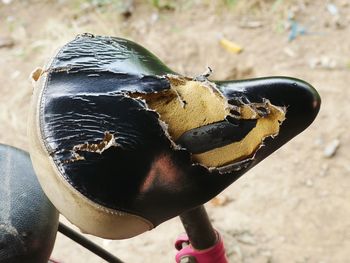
[0,0,350,263]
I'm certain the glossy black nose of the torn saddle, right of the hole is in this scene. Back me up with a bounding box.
[215,77,321,162]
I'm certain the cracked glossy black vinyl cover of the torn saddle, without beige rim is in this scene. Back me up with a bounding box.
[30,35,320,238]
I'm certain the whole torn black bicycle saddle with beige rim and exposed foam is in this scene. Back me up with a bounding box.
[29,34,320,239]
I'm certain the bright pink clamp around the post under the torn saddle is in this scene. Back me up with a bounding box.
[175,233,228,263]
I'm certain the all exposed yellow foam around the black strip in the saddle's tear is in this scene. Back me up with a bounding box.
[130,77,285,167]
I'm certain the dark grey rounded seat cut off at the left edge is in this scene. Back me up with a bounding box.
[0,144,58,263]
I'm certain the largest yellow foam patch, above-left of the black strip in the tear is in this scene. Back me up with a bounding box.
[130,79,230,141]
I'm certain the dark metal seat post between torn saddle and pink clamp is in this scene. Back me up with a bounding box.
[180,205,218,250]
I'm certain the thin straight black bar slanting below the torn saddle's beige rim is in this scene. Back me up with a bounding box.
[58,222,123,263]
